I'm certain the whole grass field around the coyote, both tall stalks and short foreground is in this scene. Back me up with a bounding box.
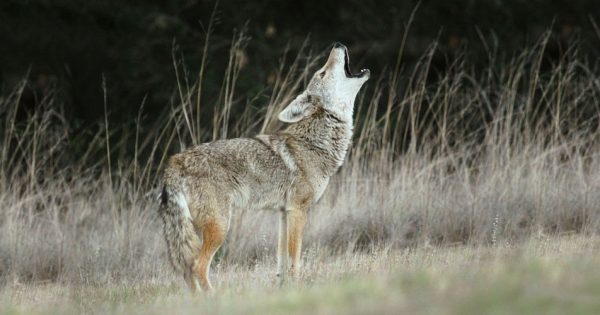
[0,37,600,314]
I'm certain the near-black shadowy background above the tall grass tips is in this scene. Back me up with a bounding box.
[0,0,600,130]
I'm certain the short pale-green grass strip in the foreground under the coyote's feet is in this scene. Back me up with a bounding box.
[0,236,600,314]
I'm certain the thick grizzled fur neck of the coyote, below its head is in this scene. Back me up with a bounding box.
[283,107,352,176]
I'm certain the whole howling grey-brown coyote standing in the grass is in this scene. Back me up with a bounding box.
[159,43,370,291]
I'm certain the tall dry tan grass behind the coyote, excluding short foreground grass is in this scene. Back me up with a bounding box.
[0,34,600,283]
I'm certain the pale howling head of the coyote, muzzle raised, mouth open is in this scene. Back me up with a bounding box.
[279,43,370,123]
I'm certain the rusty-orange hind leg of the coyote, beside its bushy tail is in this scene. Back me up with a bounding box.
[196,219,228,291]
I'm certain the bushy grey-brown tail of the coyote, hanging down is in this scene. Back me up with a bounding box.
[159,183,201,274]
